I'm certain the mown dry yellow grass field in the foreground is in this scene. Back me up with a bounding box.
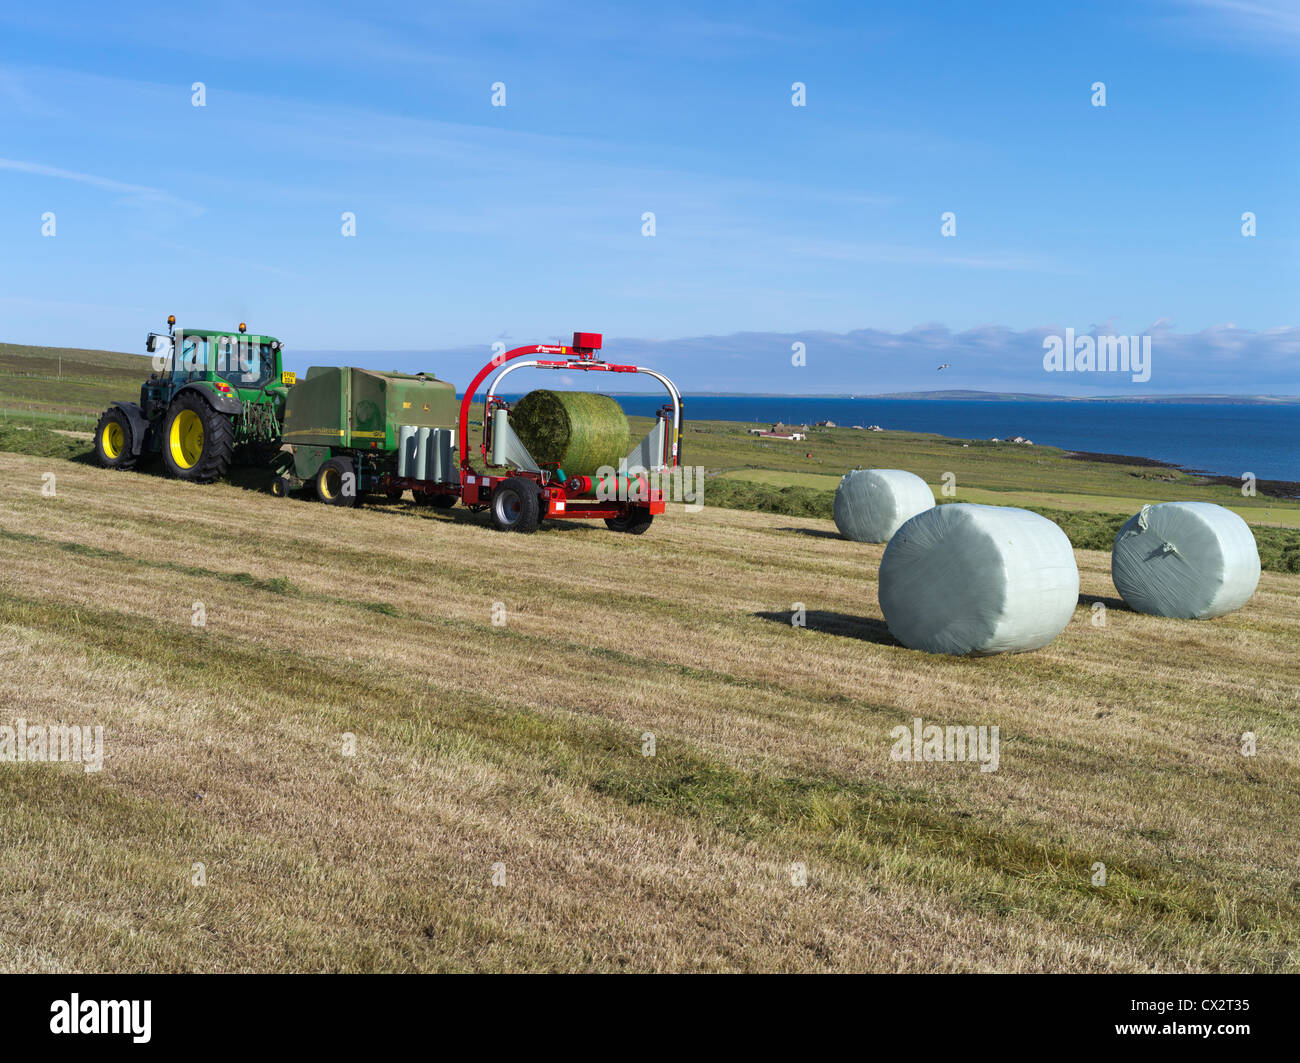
[0,454,1300,971]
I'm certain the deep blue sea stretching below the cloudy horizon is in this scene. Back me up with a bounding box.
[618,395,1300,482]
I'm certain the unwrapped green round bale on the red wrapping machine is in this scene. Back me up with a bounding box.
[510,390,631,476]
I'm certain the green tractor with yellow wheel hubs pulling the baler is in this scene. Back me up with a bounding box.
[95,317,294,483]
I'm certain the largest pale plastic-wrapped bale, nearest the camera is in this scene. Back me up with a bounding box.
[880,503,1079,655]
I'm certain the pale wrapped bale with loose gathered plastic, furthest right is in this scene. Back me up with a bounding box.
[1110,502,1260,620]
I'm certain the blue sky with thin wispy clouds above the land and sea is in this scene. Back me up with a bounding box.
[0,0,1300,394]
